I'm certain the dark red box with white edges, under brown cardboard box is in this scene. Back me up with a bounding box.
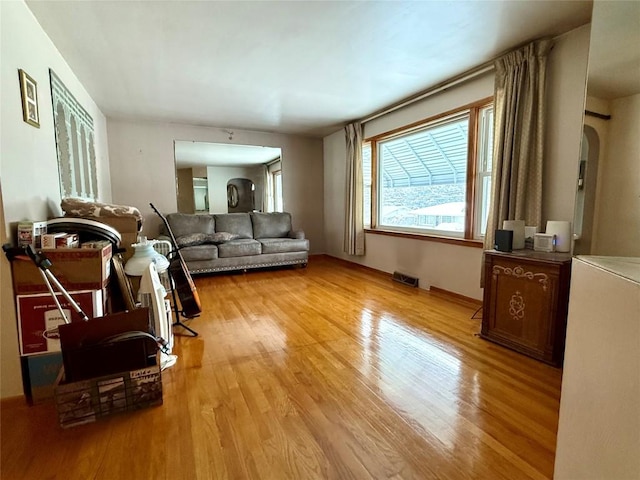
[16,290,106,355]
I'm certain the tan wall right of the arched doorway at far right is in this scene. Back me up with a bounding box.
[592,94,640,257]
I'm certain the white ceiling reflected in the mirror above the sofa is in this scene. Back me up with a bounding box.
[174,140,282,168]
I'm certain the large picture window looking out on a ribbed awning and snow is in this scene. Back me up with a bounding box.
[363,101,493,239]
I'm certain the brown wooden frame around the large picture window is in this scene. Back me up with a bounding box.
[363,97,493,247]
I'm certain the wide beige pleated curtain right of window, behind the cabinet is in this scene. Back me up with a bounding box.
[484,40,552,249]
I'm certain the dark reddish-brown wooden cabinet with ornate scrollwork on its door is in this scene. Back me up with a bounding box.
[481,250,571,366]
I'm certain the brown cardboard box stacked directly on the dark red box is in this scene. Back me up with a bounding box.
[11,244,112,295]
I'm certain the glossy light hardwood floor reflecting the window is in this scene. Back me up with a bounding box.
[0,257,561,480]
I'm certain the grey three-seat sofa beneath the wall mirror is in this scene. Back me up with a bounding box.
[161,212,309,274]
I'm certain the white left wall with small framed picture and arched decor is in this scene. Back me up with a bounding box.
[0,0,111,397]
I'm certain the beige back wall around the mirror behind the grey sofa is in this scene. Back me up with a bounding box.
[107,119,324,253]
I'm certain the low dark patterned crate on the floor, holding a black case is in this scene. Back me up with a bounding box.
[54,365,162,428]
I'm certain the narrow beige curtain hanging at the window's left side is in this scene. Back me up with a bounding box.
[344,122,364,255]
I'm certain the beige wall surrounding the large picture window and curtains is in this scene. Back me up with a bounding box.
[324,26,589,299]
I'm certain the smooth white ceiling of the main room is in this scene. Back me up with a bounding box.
[27,0,592,136]
